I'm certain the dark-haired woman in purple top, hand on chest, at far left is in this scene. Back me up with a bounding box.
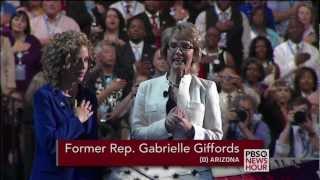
[9,11,41,100]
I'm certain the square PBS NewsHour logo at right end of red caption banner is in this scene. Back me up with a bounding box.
[244,149,269,172]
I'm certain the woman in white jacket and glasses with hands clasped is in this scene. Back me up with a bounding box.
[131,23,223,140]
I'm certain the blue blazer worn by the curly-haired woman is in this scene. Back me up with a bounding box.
[30,84,99,180]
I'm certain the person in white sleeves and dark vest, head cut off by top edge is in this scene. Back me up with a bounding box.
[195,0,250,68]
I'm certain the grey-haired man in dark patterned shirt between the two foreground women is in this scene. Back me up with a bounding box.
[86,41,131,139]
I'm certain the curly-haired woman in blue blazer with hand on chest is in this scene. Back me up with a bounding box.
[30,31,99,180]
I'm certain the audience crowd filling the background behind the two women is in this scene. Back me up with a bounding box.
[0,0,320,177]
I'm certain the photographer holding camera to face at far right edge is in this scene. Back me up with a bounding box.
[274,97,320,158]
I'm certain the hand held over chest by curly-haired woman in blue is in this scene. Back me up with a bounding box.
[74,100,93,123]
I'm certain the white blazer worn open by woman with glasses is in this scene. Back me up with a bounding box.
[130,75,223,140]
